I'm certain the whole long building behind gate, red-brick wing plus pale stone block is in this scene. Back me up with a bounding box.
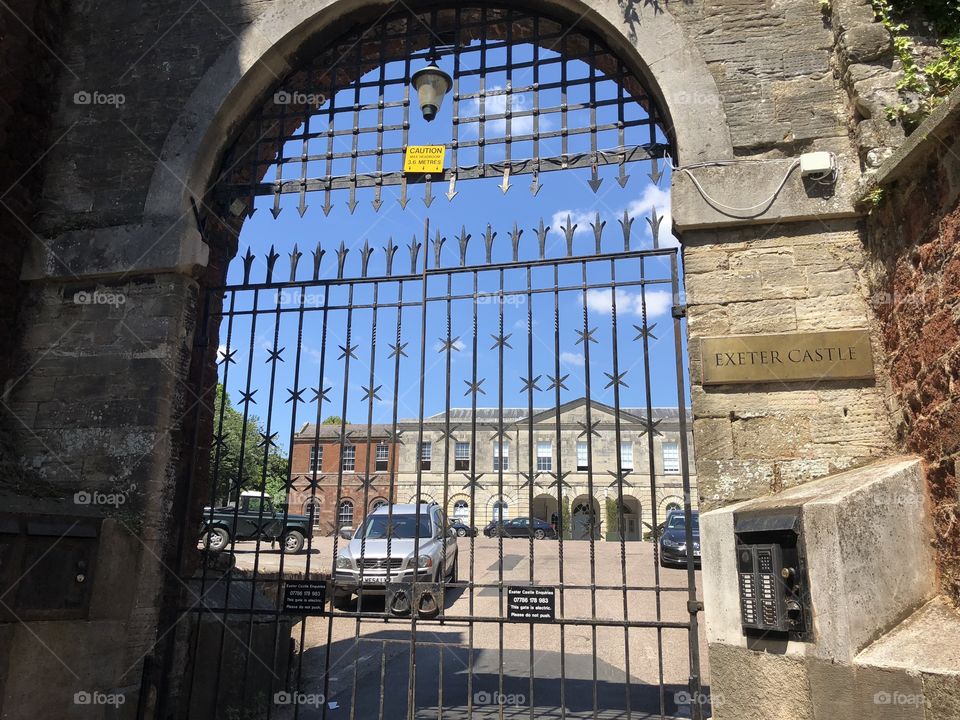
[287,398,697,541]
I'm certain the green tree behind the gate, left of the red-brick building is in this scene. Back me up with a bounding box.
[210,384,289,504]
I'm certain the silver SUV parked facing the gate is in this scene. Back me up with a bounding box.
[332,503,457,609]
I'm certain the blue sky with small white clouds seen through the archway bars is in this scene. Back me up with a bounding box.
[221,42,689,447]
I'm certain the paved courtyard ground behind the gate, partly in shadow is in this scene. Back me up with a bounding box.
[237,537,708,719]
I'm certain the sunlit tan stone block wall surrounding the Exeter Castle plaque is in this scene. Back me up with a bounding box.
[684,220,893,508]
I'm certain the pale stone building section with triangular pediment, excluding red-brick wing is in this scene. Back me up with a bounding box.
[397,398,696,540]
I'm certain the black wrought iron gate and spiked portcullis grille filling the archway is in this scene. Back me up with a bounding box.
[180,6,706,720]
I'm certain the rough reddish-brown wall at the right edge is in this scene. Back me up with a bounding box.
[868,95,960,603]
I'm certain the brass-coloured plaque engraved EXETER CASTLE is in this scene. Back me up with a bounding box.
[700,330,874,385]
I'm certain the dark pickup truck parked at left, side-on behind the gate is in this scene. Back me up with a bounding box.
[200,490,310,553]
